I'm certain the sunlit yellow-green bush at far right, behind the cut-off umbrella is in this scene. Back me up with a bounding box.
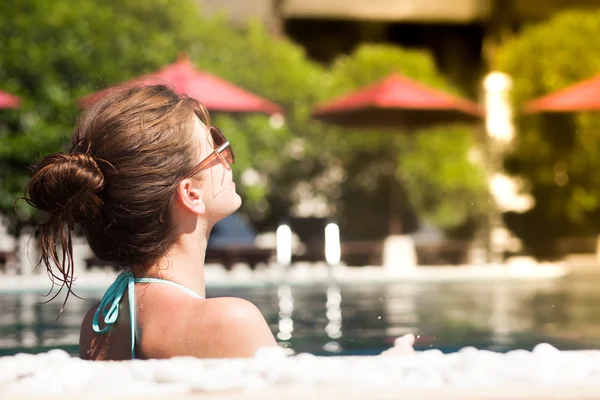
[499,11,600,254]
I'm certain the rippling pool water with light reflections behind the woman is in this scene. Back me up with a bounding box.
[0,277,600,355]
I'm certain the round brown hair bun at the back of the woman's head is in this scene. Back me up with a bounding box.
[26,153,104,222]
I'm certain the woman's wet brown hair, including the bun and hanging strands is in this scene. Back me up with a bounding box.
[24,85,209,302]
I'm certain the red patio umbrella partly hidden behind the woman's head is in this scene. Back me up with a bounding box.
[81,56,282,115]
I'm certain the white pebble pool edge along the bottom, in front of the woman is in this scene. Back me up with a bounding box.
[0,344,600,400]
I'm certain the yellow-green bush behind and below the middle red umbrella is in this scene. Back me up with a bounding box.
[324,45,487,236]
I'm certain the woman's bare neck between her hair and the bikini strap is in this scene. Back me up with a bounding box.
[135,219,210,297]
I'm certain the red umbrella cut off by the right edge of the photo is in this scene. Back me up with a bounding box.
[524,75,600,113]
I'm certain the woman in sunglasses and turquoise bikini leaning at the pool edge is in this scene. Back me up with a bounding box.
[26,85,276,360]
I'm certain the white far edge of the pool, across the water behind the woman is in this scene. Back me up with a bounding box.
[0,263,569,293]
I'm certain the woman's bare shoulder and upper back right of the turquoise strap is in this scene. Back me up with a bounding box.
[138,296,277,358]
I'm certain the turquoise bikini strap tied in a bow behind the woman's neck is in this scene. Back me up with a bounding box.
[92,271,202,359]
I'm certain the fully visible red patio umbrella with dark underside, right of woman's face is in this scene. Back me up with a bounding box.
[312,74,483,234]
